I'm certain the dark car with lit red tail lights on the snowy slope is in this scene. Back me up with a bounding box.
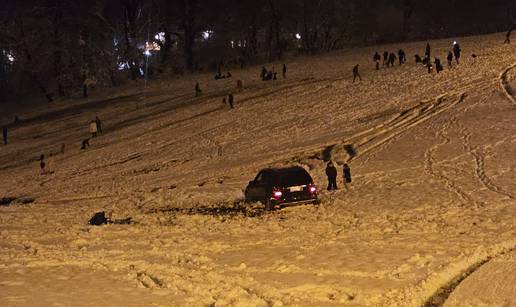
[245,167,318,210]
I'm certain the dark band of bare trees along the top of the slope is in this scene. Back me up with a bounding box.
[0,0,516,101]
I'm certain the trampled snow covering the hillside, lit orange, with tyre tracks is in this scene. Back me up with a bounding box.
[0,34,516,306]
